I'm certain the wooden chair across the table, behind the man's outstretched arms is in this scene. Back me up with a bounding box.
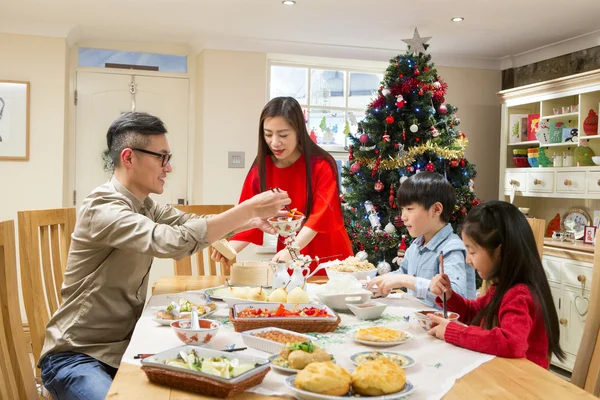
[173,204,235,276]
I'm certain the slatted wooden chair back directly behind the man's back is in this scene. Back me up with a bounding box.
[17,208,76,372]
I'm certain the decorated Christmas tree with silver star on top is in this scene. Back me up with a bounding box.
[342,29,480,273]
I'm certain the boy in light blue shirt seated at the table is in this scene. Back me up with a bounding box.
[368,172,475,307]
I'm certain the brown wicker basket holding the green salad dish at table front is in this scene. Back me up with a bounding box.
[142,366,270,399]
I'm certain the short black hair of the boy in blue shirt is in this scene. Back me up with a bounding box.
[396,172,456,223]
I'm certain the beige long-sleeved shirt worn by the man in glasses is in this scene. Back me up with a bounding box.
[40,177,209,368]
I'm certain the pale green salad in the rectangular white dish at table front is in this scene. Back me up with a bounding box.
[165,350,260,378]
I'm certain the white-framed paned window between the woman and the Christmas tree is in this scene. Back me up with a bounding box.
[269,62,383,151]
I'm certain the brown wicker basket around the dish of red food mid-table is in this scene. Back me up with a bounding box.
[229,309,342,333]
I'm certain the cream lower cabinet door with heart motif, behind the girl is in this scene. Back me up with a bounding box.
[559,288,590,355]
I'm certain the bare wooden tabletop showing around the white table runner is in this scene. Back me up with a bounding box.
[106,276,597,400]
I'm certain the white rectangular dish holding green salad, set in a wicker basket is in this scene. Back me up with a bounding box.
[142,346,270,384]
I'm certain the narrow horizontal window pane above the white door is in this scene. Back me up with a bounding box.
[78,47,187,74]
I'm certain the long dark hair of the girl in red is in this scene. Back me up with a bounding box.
[462,201,565,360]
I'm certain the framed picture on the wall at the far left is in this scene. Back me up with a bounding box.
[0,80,29,161]
